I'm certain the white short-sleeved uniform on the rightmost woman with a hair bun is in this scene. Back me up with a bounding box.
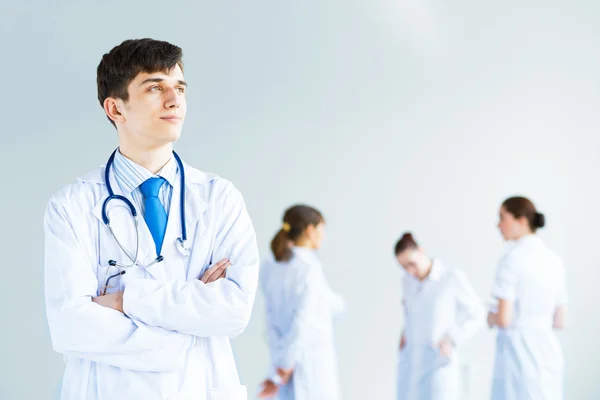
[492,235,567,400]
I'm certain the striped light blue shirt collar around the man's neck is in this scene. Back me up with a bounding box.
[113,150,178,194]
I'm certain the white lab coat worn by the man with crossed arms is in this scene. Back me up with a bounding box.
[44,162,258,400]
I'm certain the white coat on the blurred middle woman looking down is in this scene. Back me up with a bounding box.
[397,260,485,400]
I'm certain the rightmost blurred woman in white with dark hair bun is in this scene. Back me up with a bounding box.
[488,197,567,400]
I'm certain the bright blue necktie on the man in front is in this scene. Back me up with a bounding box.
[140,178,167,255]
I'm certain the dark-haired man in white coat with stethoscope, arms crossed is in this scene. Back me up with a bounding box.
[44,39,258,400]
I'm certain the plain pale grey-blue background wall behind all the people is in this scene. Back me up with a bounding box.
[0,0,600,400]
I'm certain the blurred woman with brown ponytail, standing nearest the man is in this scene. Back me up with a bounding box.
[259,205,344,400]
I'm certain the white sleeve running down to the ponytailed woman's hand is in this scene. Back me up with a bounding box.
[275,267,320,369]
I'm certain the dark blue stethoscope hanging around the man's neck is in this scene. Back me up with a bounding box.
[102,150,191,288]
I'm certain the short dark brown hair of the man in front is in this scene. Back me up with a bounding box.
[96,39,183,125]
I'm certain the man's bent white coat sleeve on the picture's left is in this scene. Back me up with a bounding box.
[44,200,195,371]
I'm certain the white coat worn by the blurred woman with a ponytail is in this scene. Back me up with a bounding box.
[261,247,344,400]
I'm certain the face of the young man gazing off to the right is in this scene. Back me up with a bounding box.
[116,65,186,149]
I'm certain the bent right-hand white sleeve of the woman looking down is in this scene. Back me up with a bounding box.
[448,271,485,347]
